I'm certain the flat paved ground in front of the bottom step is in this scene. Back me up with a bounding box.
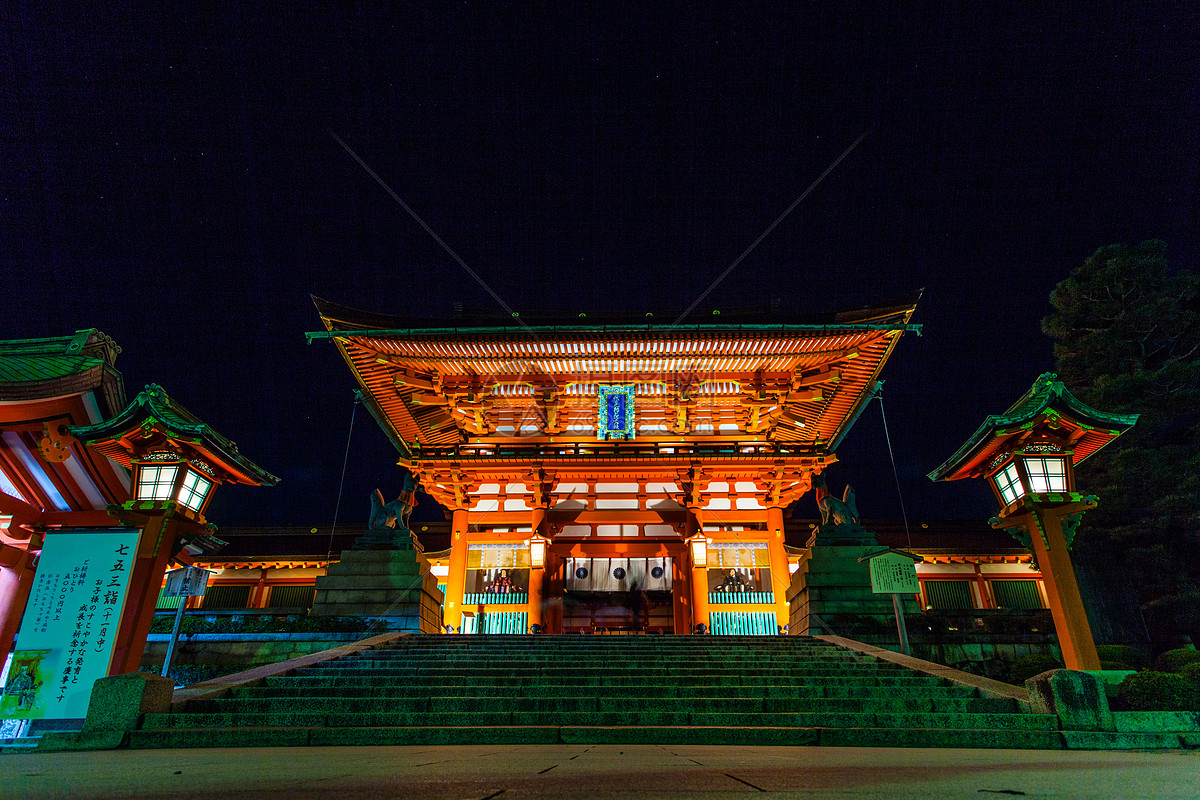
[0,745,1200,800]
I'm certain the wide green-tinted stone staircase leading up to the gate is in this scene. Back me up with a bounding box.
[130,636,1063,748]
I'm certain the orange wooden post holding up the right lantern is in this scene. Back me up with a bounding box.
[1025,506,1100,670]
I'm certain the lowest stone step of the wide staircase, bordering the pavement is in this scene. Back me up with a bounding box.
[130,726,1063,750]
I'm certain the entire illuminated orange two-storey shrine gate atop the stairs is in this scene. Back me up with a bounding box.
[308,297,918,633]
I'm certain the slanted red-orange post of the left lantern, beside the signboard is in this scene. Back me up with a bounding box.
[108,520,179,675]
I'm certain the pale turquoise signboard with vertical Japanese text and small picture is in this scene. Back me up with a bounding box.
[0,529,140,720]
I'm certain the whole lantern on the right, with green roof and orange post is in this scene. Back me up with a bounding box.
[929,373,1138,669]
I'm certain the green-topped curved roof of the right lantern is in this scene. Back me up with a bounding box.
[929,372,1138,481]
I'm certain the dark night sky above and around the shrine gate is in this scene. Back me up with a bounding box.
[0,2,1200,525]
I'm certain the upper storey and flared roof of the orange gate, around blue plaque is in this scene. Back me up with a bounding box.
[310,297,919,507]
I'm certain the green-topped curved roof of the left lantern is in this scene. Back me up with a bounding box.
[68,384,280,486]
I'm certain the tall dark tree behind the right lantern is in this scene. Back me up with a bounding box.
[1042,241,1200,639]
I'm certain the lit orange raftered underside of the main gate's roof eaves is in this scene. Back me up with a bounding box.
[338,330,900,446]
